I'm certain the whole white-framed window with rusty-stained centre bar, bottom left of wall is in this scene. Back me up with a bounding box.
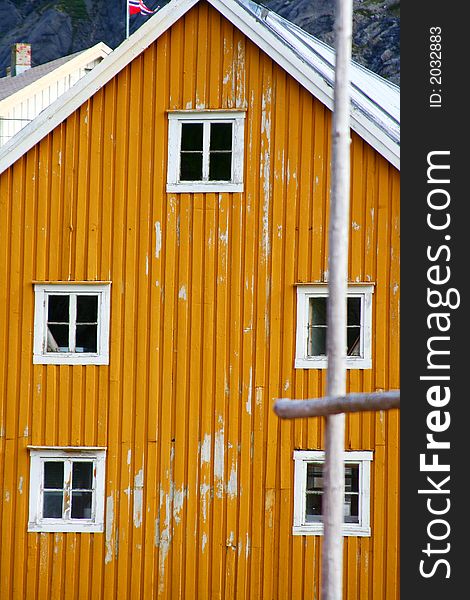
[28,446,106,532]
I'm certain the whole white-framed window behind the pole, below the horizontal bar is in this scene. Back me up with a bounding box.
[293,450,372,536]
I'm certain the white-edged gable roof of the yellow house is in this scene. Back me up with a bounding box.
[0,0,400,173]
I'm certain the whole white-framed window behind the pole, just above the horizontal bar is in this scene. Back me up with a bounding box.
[295,284,374,369]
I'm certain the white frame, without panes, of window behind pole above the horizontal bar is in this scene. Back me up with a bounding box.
[295,284,374,369]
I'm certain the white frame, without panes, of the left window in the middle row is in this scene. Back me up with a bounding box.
[33,283,111,365]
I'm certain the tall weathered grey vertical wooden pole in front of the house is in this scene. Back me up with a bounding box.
[321,0,352,600]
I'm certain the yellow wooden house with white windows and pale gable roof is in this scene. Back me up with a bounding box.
[0,0,399,600]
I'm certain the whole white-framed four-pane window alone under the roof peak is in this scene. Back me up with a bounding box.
[167,110,245,192]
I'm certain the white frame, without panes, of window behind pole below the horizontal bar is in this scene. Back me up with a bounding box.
[292,450,373,537]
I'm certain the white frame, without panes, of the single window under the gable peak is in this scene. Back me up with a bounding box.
[166,110,245,192]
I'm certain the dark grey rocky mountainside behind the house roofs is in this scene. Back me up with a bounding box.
[0,0,400,84]
